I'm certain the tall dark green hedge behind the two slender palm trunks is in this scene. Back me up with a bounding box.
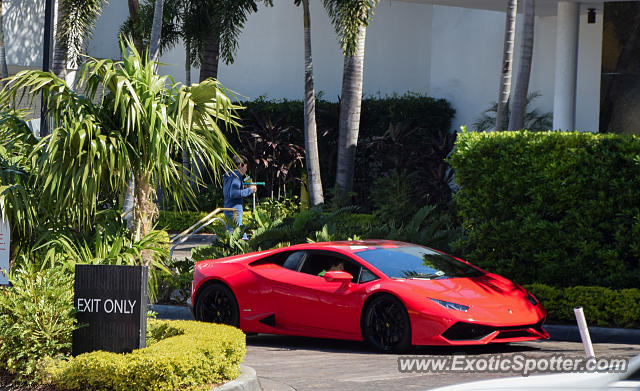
[236,92,455,211]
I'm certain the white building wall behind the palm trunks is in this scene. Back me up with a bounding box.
[4,0,602,130]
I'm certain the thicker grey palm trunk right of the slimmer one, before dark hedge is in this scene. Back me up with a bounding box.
[336,26,367,204]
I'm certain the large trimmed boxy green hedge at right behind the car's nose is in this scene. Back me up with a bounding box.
[450,131,640,288]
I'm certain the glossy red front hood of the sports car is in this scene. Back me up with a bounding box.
[402,274,544,325]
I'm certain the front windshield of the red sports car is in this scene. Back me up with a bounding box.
[357,246,483,280]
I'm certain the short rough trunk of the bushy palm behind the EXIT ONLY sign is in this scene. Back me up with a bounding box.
[133,173,158,266]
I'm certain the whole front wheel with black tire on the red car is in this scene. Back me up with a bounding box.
[362,295,411,353]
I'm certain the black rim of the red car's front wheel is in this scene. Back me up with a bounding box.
[365,300,407,351]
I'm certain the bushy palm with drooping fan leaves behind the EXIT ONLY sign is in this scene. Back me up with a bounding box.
[0,42,238,263]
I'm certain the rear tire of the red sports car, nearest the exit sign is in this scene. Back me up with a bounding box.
[195,283,240,327]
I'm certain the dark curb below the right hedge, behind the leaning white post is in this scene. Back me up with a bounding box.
[543,324,640,345]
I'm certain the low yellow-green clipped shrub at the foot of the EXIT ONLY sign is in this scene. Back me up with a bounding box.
[46,321,246,391]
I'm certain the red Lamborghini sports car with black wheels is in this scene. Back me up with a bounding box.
[191,240,548,351]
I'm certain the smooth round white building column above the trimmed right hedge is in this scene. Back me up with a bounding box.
[553,1,580,130]
